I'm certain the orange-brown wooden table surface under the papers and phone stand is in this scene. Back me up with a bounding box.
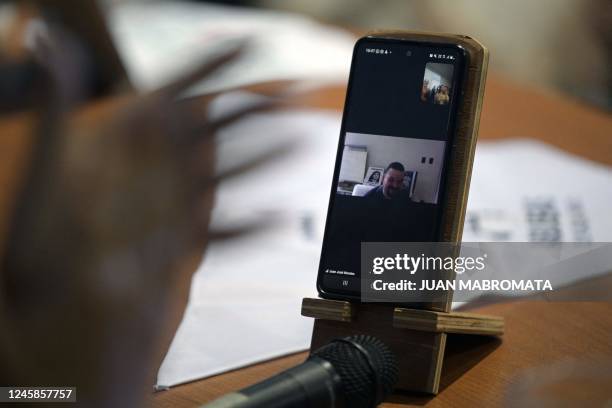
[151,76,612,408]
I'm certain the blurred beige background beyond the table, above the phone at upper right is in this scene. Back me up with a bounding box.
[258,0,612,109]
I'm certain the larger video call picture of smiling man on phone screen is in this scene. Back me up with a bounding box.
[336,132,445,204]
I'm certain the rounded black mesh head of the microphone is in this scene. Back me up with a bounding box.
[311,334,399,408]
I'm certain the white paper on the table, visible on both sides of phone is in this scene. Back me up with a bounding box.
[157,98,612,388]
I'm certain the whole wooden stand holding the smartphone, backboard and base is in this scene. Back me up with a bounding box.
[302,31,504,394]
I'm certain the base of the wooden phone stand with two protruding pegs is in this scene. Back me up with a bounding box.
[302,298,504,394]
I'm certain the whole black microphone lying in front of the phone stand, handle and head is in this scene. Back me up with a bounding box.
[200,335,398,408]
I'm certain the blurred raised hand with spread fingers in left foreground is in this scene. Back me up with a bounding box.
[0,27,284,406]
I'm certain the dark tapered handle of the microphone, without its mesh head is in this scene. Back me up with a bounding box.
[200,357,343,408]
